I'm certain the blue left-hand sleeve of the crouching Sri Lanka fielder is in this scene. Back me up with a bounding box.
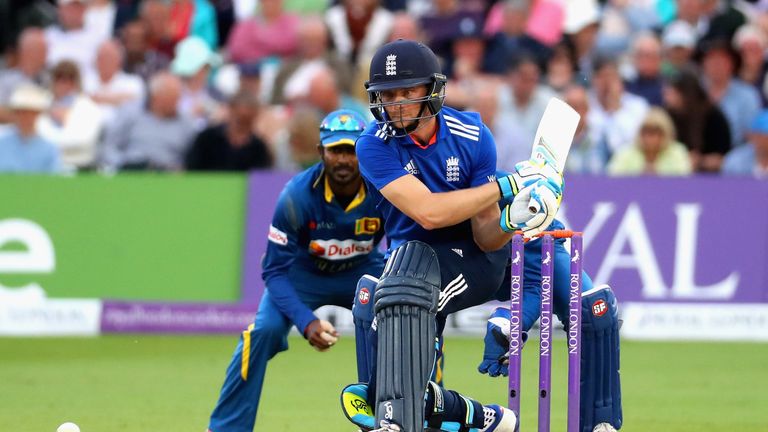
[262,187,317,334]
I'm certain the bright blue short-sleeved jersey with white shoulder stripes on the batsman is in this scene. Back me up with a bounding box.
[356,107,496,250]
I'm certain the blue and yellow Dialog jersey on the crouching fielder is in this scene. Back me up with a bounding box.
[262,163,384,331]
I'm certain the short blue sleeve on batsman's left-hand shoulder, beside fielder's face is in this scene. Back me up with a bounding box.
[355,135,408,190]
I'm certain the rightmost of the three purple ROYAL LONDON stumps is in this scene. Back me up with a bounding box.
[567,233,584,432]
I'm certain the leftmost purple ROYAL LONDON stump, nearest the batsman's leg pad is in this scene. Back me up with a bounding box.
[508,234,525,421]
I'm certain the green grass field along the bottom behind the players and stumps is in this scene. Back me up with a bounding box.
[0,335,768,432]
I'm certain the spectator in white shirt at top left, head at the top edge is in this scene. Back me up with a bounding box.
[45,0,104,74]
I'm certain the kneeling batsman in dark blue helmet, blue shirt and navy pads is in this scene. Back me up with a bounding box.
[342,40,562,432]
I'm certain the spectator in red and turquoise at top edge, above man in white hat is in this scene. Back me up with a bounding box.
[167,0,219,49]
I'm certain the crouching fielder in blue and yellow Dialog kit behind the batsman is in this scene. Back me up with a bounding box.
[208,110,384,432]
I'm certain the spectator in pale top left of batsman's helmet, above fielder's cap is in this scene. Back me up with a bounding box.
[271,17,352,105]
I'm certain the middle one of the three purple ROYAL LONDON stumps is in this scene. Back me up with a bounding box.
[539,234,555,432]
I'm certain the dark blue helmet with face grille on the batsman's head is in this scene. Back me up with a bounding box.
[365,39,447,136]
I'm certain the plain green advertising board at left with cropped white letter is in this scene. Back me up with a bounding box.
[0,174,246,302]
